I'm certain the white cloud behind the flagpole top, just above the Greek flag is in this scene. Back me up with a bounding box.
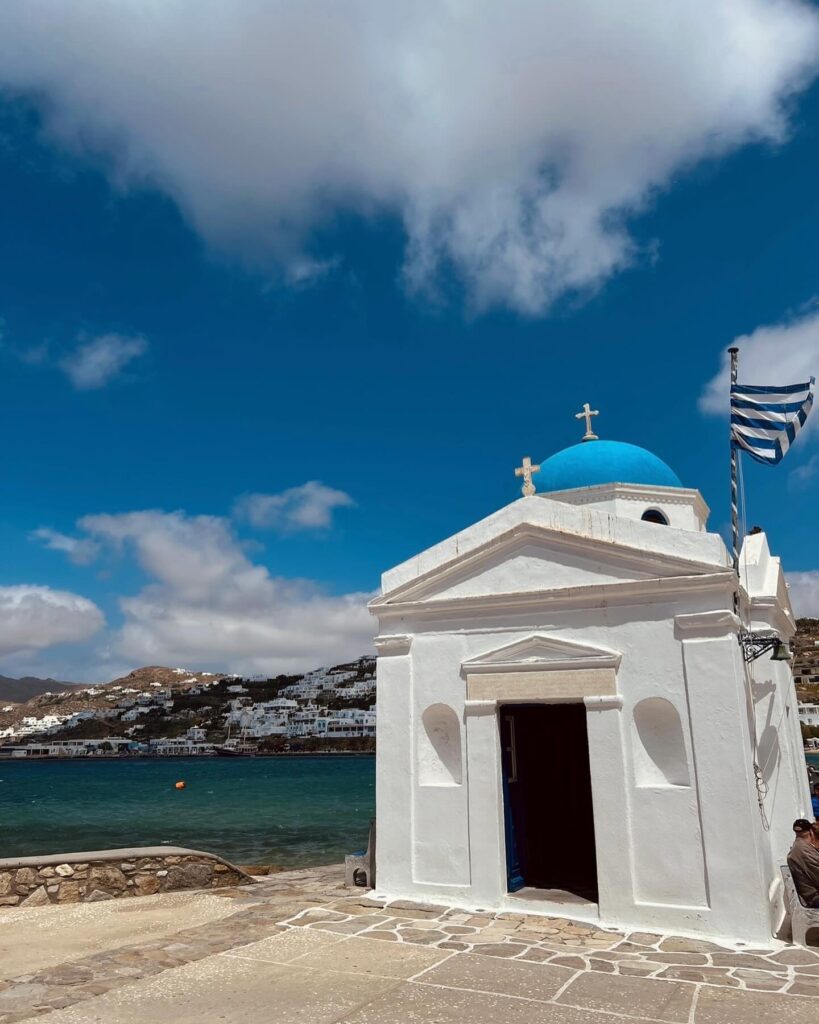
[699,311,819,413]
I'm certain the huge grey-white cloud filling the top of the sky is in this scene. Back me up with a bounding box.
[0,0,819,313]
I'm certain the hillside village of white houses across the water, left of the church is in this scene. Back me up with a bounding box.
[0,657,376,759]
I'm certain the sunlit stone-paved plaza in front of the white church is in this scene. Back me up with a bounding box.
[0,867,819,1024]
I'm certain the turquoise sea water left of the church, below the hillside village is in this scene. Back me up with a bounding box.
[0,756,376,865]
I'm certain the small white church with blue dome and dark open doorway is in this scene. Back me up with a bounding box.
[371,406,811,943]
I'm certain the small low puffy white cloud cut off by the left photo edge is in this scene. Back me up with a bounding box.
[0,585,104,656]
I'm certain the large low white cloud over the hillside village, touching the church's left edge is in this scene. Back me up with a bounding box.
[80,511,374,674]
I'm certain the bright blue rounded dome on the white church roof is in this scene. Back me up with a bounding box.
[531,440,683,494]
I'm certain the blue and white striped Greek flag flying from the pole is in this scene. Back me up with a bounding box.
[731,377,815,465]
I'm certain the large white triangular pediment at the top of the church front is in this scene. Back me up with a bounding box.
[374,524,706,606]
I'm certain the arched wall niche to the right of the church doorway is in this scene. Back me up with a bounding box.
[632,697,690,786]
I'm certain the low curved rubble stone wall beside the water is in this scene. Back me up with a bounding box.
[0,847,254,908]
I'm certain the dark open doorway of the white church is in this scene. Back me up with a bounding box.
[499,703,597,902]
